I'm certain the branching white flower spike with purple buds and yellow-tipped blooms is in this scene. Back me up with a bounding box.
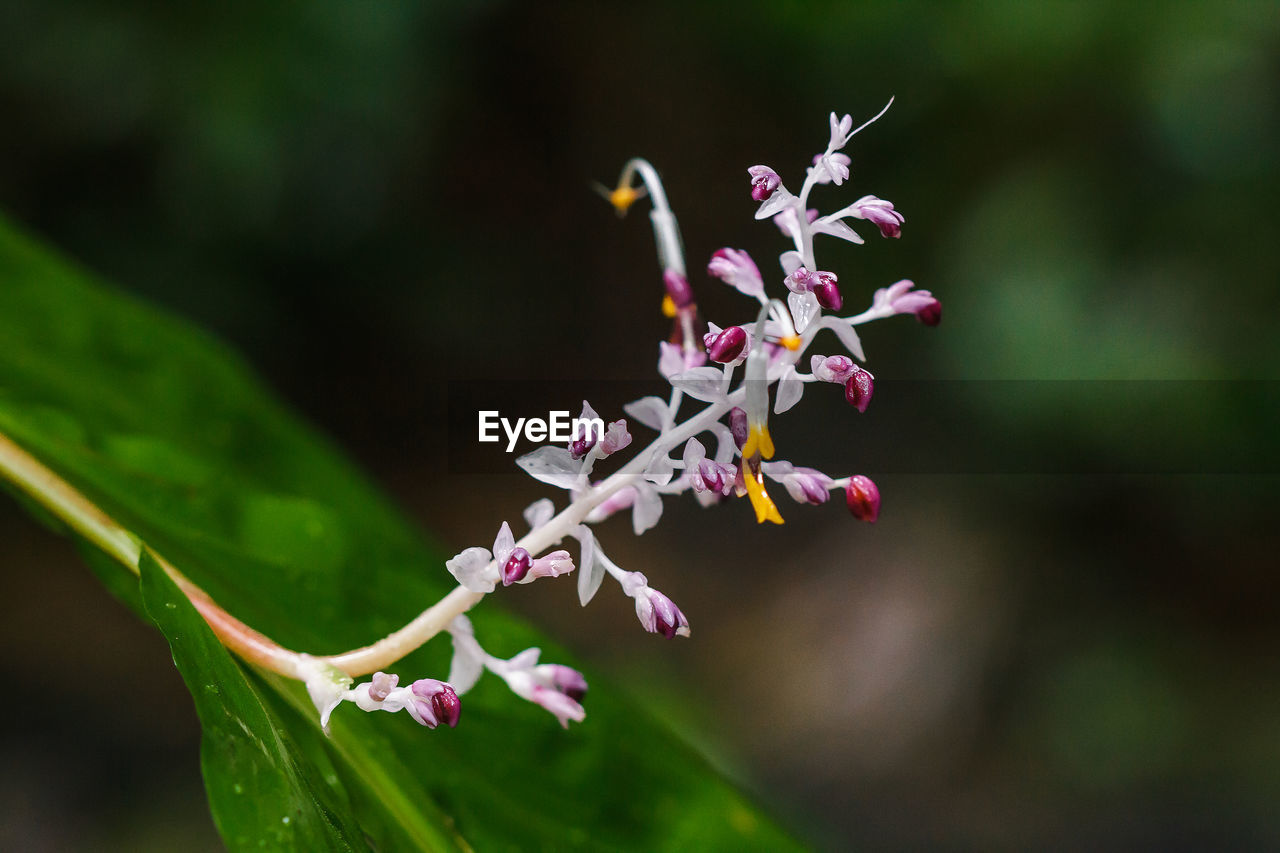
[293,101,942,729]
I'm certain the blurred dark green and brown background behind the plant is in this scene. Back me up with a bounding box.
[0,0,1280,850]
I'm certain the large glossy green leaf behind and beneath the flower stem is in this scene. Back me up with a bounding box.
[0,216,795,850]
